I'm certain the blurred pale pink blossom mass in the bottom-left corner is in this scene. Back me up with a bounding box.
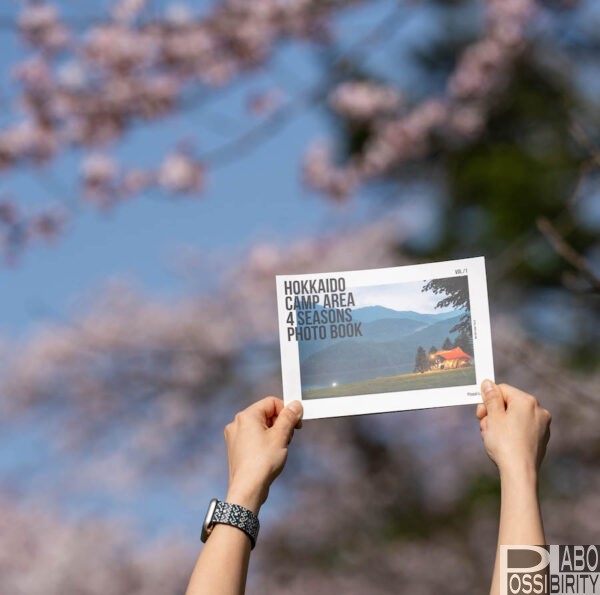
[0,498,192,595]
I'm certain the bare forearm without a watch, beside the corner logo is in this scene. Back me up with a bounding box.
[491,469,546,595]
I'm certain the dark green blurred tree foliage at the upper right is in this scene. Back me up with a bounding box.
[336,2,600,364]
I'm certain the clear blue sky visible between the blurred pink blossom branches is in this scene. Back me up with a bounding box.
[0,1,440,337]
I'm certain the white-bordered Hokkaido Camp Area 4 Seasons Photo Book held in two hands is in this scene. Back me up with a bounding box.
[276,257,494,419]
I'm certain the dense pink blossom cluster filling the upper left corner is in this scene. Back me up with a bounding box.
[0,0,370,237]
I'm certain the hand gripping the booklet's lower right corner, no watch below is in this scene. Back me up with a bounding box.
[477,380,551,476]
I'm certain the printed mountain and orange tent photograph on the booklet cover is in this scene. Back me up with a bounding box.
[295,275,475,399]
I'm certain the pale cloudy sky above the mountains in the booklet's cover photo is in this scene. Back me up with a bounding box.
[349,280,453,314]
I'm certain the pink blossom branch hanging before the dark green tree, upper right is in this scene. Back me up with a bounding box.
[304,0,534,199]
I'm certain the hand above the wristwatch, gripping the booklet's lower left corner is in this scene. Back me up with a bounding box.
[225,397,302,514]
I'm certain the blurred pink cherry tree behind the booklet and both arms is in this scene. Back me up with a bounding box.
[0,222,600,594]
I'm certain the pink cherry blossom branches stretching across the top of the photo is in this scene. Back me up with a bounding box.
[0,0,584,254]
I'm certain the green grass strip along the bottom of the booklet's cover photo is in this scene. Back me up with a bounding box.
[302,366,476,399]
